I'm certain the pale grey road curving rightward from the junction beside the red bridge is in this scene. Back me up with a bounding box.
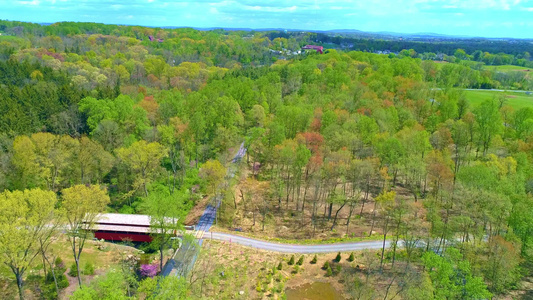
[204,232,391,253]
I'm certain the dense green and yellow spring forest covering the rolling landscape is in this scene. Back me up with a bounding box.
[0,21,533,299]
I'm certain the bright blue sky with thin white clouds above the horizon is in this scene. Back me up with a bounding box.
[0,0,533,38]
